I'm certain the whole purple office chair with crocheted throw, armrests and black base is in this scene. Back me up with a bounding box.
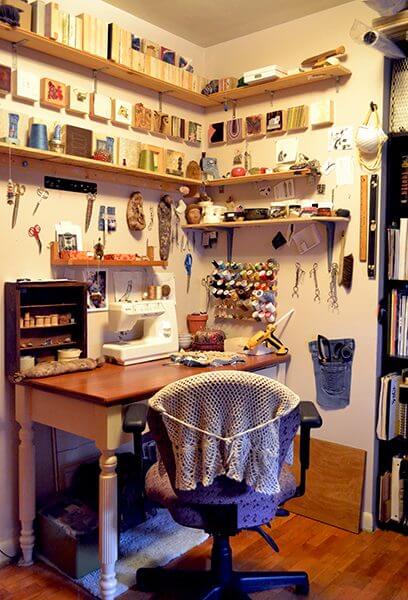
[124,370,322,600]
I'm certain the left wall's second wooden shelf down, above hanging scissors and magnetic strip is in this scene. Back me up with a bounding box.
[0,142,201,191]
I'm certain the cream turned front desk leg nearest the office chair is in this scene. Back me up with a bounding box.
[99,450,118,600]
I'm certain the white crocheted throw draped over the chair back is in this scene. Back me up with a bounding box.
[149,370,299,494]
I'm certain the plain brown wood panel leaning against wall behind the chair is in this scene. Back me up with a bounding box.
[287,437,366,533]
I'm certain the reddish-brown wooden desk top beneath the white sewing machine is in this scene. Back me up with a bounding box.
[18,354,290,406]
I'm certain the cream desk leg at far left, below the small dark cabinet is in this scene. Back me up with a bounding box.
[17,392,35,567]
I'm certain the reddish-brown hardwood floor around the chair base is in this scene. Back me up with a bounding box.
[0,515,408,600]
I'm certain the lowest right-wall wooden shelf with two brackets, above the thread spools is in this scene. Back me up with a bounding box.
[182,217,350,262]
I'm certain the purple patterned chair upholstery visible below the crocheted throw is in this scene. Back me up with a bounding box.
[145,463,296,529]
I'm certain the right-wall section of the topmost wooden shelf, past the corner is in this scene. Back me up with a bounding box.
[209,65,351,105]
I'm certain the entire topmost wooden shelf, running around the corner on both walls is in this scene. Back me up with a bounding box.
[0,23,351,108]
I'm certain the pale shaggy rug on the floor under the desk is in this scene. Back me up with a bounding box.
[75,509,208,598]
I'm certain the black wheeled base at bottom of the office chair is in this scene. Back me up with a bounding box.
[136,568,309,600]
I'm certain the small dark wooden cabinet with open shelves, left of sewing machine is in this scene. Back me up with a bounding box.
[5,281,87,375]
